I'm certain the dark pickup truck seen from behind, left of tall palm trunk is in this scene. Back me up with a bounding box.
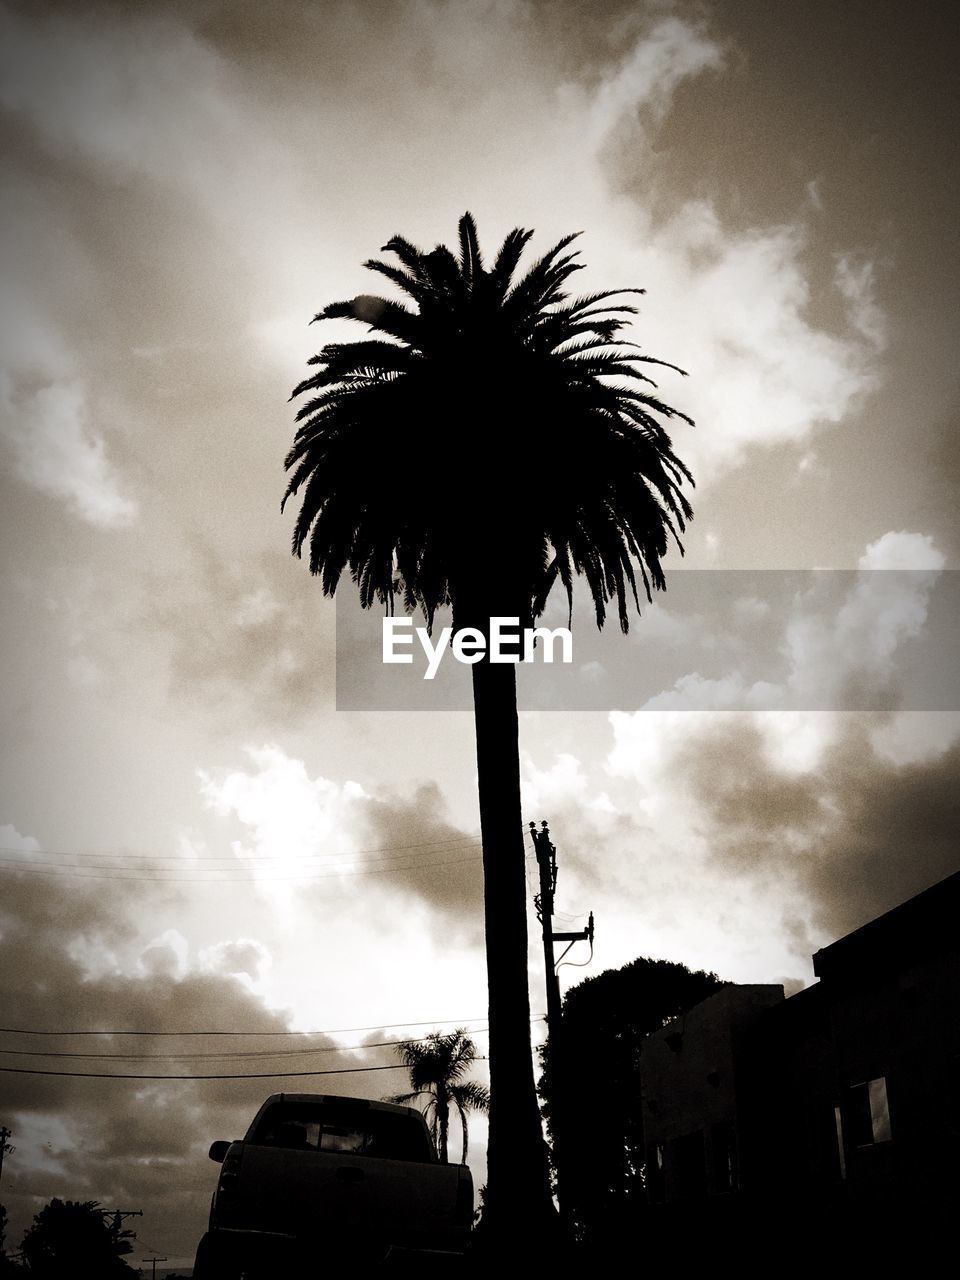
[193,1093,474,1280]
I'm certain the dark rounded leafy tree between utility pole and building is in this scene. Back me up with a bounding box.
[538,956,724,1247]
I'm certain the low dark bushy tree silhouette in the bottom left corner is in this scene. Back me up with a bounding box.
[20,1199,137,1280]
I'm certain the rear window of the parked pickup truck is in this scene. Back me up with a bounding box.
[247,1101,435,1161]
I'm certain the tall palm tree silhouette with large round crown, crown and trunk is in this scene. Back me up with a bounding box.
[284,214,691,1238]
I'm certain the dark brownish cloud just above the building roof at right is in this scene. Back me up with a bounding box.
[680,719,960,950]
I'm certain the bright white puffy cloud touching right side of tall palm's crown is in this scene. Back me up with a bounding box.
[634,201,883,485]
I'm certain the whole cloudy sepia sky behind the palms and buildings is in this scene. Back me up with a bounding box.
[0,0,960,1265]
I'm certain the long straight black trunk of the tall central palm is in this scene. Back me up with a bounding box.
[472,650,556,1244]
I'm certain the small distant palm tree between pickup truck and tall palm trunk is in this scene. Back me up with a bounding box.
[387,1027,490,1165]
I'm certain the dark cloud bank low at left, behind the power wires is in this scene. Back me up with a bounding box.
[0,872,393,1257]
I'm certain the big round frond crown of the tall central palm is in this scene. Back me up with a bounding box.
[284,214,691,640]
